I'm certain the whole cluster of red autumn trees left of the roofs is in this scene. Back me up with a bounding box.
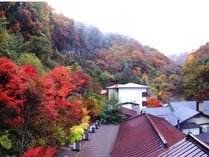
[0,58,102,157]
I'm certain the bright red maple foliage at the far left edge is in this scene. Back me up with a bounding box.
[0,58,26,127]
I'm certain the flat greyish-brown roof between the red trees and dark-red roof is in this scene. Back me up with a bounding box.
[55,124,119,157]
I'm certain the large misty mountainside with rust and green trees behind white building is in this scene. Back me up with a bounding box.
[0,2,181,102]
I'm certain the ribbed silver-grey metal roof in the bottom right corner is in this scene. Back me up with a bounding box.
[159,133,209,157]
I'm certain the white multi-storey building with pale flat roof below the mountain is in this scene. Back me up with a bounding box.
[107,83,149,110]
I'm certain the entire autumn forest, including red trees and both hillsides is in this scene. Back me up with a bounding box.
[0,2,209,157]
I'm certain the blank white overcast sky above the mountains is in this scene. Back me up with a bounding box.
[46,0,209,56]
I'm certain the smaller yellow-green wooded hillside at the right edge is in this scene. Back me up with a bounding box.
[183,43,209,100]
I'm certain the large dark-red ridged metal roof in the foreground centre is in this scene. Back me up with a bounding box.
[112,113,185,157]
